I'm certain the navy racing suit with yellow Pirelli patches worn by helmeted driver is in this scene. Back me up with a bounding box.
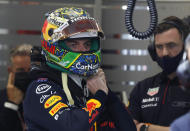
[24,67,136,131]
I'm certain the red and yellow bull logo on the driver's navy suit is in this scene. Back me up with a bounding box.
[83,99,101,117]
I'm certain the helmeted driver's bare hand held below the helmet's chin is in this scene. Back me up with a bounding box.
[87,69,108,94]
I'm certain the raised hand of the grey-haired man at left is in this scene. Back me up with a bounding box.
[7,72,24,105]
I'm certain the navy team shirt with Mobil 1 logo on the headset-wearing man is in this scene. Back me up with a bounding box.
[129,73,190,126]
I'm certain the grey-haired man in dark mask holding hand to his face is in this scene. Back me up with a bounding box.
[0,44,32,131]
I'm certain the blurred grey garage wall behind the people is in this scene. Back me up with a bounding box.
[0,0,190,102]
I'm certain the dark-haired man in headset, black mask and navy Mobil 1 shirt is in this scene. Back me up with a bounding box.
[129,16,190,131]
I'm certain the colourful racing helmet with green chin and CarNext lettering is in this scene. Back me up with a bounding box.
[41,7,104,76]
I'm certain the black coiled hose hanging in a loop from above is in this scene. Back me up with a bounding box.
[125,0,158,39]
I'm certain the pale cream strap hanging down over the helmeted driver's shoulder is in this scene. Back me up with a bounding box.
[61,73,74,105]
